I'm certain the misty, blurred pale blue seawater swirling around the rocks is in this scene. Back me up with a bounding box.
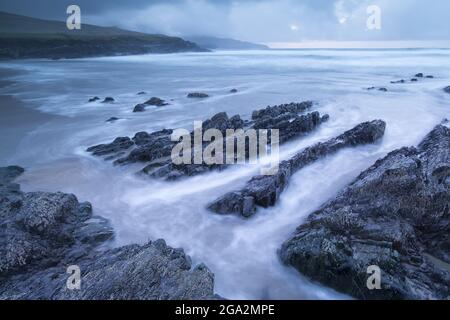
[0,49,450,299]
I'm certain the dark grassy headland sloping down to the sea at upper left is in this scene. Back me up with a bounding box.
[0,12,206,59]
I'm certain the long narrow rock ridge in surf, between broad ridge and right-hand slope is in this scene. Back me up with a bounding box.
[208,120,386,217]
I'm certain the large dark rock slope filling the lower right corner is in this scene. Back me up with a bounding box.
[280,125,450,299]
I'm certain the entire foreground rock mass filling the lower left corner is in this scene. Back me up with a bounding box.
[0,167,215,299]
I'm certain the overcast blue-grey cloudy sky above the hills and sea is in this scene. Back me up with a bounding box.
[0,0,450,42]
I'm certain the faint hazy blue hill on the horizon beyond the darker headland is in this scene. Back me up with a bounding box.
[184,36,269,50]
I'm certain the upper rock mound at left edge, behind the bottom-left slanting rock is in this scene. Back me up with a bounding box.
[0,167,113,276]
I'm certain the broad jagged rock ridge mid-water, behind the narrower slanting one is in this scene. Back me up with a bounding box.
[87,101,329,180]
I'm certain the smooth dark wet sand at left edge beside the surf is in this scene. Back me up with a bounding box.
[0,69,55,166]
